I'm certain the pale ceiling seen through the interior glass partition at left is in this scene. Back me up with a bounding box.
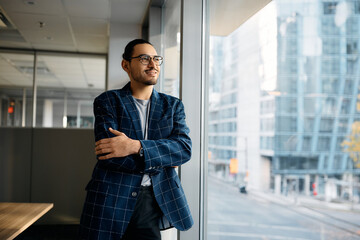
[0,52,106,90]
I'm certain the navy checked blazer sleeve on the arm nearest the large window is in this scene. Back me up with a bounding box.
[140,101,191,173]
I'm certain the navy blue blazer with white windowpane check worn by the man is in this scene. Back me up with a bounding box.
[80,83,193,239]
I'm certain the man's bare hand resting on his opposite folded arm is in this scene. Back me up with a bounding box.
[95,128,141,160]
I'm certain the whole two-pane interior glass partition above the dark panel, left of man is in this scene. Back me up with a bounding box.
[0,51,106,128]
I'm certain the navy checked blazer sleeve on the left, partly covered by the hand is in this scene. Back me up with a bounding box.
[94,93,144,173]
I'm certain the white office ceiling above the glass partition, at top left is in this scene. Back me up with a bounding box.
[0,0,150,53]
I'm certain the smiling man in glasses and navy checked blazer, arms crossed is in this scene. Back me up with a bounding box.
[80,39,193,240]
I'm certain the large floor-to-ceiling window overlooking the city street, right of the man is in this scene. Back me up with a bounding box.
[207,0,360,240]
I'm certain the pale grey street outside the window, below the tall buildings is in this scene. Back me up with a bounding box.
[207,176,360,240]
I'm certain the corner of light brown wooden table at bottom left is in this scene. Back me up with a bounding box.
[0,202,54,240]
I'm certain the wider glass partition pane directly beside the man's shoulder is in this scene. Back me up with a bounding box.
[36,55,106,128]
